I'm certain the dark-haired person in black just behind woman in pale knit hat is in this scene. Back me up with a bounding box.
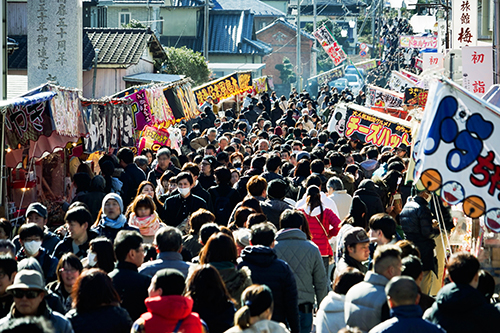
[116,148,146,207]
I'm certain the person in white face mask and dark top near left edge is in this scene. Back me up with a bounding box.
[17,223,58,282]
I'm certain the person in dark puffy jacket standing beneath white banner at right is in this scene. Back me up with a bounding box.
[399,191,439,293]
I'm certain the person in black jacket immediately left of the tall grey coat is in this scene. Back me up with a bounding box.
[238,223,300,333]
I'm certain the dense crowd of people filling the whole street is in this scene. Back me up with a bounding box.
[0,87,500,333]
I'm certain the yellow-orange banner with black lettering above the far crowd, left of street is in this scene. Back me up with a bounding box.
[193,72,252,105]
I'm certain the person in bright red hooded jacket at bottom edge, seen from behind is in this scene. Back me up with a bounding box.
[132,268,203,333]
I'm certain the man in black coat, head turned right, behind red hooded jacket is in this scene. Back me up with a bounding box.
[109,231,151,321]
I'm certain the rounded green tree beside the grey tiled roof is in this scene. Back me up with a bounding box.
[162,46,210,85]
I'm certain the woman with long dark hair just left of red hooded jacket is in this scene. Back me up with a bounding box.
[66,268,132,333]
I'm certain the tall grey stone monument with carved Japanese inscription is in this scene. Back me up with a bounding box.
[28,0,83,89]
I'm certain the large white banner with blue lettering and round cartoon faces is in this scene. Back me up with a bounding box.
[413,78,500,224]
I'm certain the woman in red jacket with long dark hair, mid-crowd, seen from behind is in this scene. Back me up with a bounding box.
[300,185,341,272]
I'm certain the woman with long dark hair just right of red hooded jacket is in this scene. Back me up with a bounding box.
[186,265,236,333]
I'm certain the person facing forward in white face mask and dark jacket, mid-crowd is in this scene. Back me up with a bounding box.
[163,171,207,227]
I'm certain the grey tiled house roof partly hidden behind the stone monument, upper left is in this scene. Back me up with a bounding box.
[9,28,166,70]
